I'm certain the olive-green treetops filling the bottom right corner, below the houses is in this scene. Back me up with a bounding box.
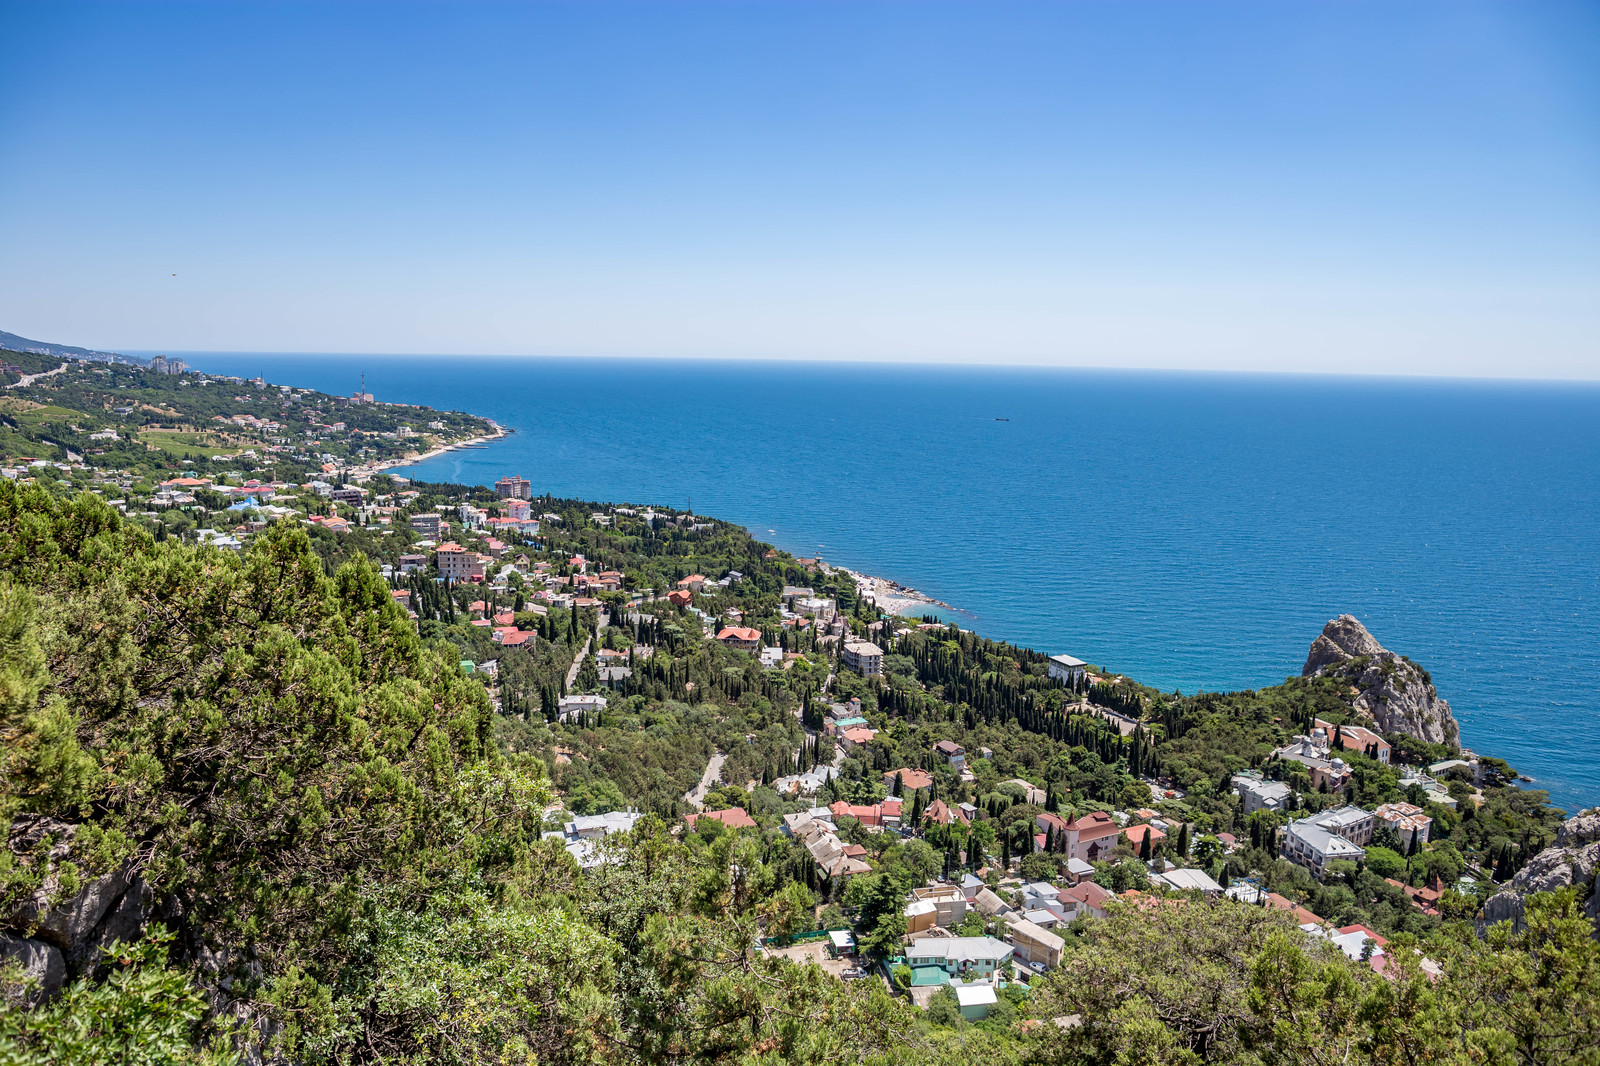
[1034,892,1600,1066]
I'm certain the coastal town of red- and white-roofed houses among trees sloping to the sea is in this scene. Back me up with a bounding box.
[0,347,1594,1043]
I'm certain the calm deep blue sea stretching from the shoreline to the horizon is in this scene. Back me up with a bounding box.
[144,352,1600,810]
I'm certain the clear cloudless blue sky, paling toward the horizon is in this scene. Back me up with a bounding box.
[0,0,1600,378]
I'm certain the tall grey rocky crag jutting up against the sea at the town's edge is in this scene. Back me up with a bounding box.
[1301,615,1461,744]
